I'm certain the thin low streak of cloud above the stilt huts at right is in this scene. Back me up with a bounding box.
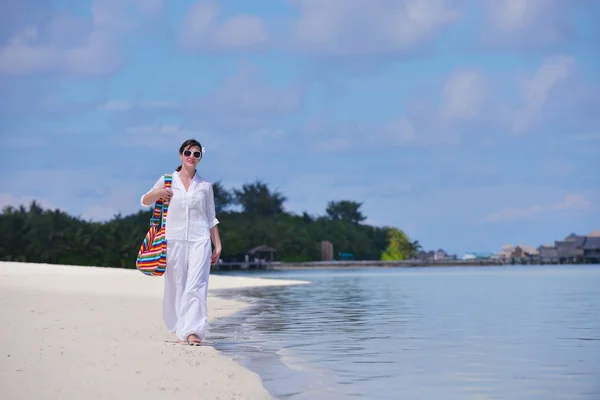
[484,194,592,223]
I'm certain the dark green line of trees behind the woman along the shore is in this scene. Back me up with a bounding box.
[0,181,420,268]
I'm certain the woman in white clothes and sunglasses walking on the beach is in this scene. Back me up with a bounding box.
[141,139,221,345]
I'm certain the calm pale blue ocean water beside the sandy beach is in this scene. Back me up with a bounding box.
[207,265,600,400]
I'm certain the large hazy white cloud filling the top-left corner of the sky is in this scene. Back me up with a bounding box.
[0,0,158,77]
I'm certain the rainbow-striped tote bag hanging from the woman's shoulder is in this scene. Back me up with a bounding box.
[136,175,173,276]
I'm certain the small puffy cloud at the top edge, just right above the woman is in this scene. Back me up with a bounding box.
[179,1,269,50]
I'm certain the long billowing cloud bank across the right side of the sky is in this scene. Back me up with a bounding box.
[296,54,599,151]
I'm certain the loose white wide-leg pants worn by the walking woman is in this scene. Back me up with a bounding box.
[163,238,212,340]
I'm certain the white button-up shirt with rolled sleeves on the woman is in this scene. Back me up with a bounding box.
[140,171,219,241]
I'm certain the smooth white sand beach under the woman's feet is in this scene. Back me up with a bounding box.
[0,262,303,400]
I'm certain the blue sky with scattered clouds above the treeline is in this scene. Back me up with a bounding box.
[0,0,600,255]
